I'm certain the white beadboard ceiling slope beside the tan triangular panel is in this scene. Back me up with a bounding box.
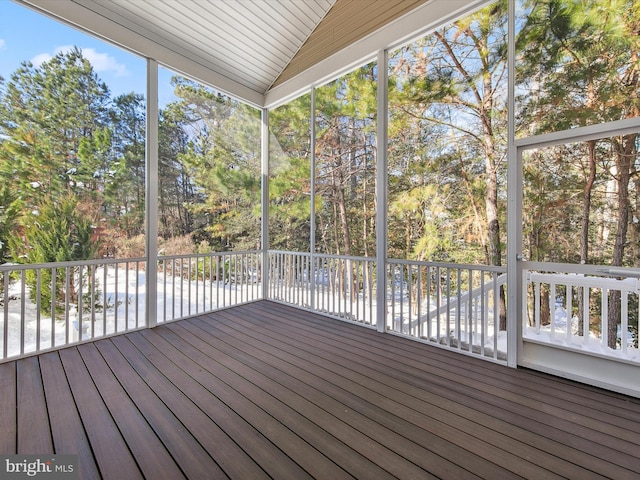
[74,0,335,92]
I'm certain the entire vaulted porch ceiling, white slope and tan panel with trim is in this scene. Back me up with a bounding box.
[17,0,483,106]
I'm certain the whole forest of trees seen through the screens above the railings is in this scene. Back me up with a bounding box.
[0,0,640,344]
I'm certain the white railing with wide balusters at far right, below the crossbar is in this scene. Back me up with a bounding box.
[523,264,640,361]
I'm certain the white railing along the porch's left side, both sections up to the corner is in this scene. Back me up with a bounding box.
[0,251,262,361]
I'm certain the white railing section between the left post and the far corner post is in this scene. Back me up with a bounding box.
[157,251,262,323]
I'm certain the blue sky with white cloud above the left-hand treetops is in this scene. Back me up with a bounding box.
[0,0,171,105]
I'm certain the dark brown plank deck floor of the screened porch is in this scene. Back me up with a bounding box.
[0,301,640,480]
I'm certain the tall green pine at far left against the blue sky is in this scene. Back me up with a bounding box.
[0,48,109,260]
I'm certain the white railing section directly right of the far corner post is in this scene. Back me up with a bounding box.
[269,250,376,326]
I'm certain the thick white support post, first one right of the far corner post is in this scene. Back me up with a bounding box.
[376,50,389,332]
